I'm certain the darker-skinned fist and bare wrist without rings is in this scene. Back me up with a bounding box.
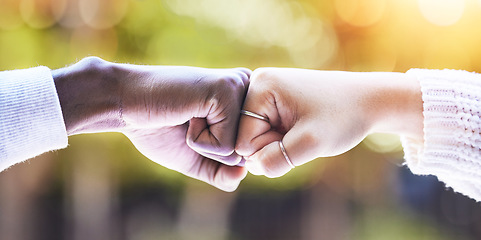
[53,58,250,191]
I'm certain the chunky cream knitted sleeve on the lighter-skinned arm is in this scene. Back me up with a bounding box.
[401,69,481,201]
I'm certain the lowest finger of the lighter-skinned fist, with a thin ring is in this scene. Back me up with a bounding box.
[246,126,319,178]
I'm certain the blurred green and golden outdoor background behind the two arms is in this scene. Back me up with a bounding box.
[0,0,481,240]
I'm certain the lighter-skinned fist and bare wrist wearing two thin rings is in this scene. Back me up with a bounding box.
[236,68,423,177]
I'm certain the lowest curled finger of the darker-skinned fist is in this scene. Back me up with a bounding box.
[189,158,247,192]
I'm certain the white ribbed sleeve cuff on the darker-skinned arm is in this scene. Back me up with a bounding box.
[0,67,68,171]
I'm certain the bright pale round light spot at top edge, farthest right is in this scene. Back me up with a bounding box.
[419,0,466,26]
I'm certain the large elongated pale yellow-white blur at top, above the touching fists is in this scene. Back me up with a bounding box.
[166,0,337,68]
